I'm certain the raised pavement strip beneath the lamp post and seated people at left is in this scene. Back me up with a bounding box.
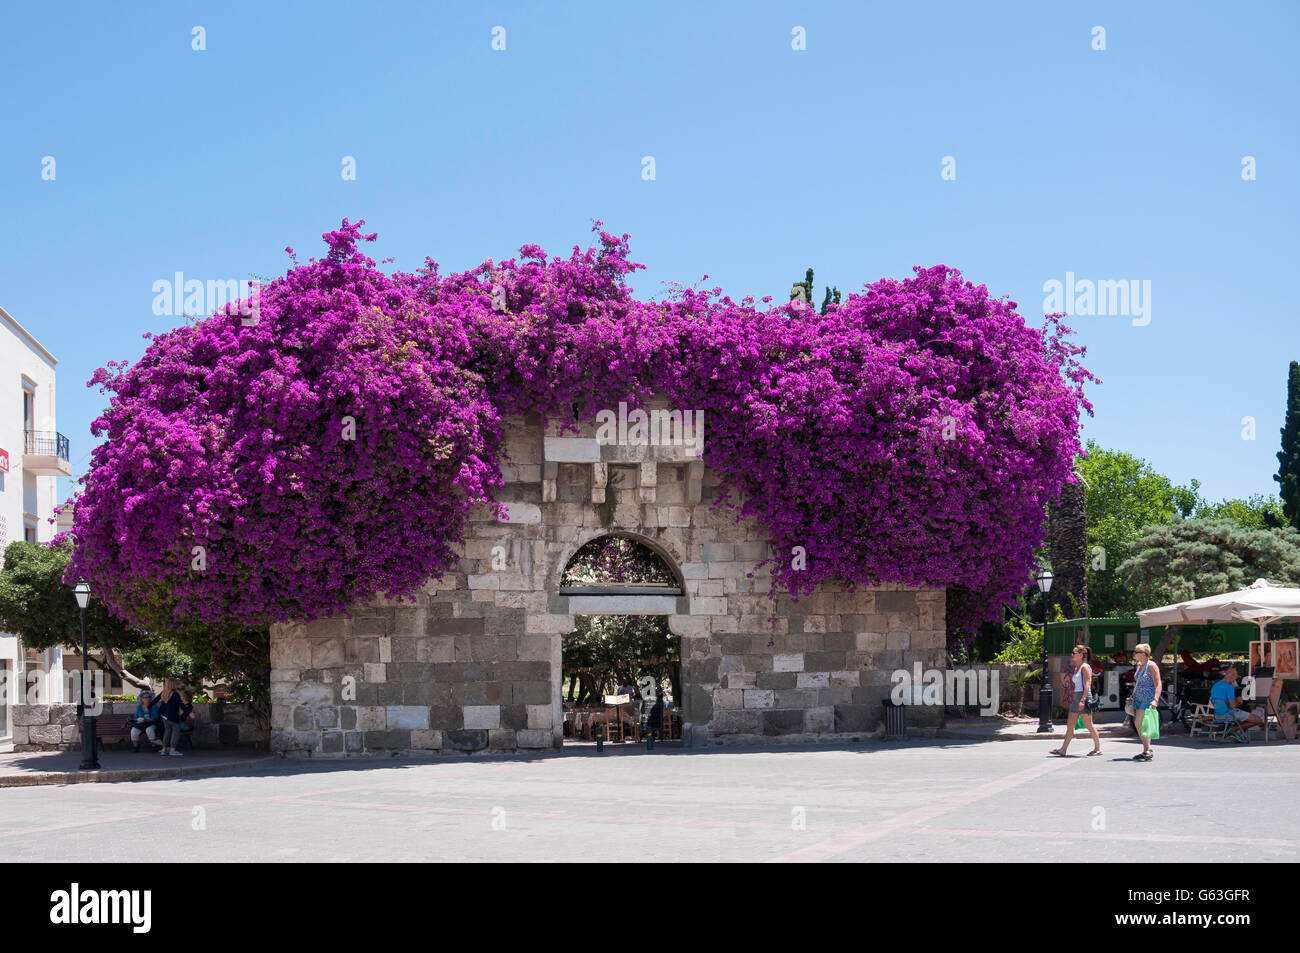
[0,748,273,788]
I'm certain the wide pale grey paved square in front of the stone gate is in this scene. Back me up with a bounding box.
[0,740,1300,862]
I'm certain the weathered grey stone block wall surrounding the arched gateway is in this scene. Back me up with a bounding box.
[270,405,946,757]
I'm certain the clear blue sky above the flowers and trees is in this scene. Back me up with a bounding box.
[0,3,1300,498]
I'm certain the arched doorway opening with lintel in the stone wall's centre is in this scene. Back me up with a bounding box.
[560,533,683,744]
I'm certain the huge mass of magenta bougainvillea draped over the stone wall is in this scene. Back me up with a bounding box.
[70,220,1091,642]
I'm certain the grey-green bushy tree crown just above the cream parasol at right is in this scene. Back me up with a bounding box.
[1118,519,1300,608]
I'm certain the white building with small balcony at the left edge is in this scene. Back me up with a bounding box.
[0,301,72,741]
